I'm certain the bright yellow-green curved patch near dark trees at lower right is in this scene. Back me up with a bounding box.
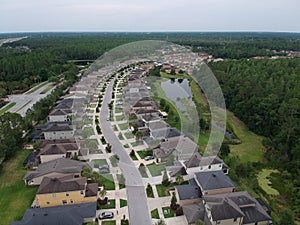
[257,169,279,195]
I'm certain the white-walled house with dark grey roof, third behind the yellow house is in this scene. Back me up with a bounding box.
[42,123,74,139]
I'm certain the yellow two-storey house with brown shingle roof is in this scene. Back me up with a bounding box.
[35,174,98,208]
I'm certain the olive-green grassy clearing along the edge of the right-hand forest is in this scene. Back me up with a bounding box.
[227,111,263,163]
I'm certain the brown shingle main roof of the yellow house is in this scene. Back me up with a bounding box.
[37,175,87,194]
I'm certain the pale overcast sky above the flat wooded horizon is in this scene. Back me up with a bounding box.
[0,0,300,33]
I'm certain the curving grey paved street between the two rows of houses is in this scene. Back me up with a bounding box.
[100,79,152,225]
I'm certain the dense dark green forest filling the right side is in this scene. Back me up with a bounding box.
[210,59,300,220]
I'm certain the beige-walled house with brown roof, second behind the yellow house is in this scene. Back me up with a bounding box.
[38,143,79,163]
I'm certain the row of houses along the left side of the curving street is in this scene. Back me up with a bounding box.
[11,80,99,225]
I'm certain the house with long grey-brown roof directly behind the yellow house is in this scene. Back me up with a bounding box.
[23,158,93,185]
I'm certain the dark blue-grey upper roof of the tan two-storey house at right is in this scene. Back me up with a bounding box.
[195,171,235,191]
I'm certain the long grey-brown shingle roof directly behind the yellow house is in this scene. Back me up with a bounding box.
[24,158,92,180]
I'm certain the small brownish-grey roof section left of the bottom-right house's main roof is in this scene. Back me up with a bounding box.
[182,203,205,224]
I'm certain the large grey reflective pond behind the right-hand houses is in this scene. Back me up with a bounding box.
[161,79,194,111]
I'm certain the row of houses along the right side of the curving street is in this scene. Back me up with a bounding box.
[123,65,271,225]
